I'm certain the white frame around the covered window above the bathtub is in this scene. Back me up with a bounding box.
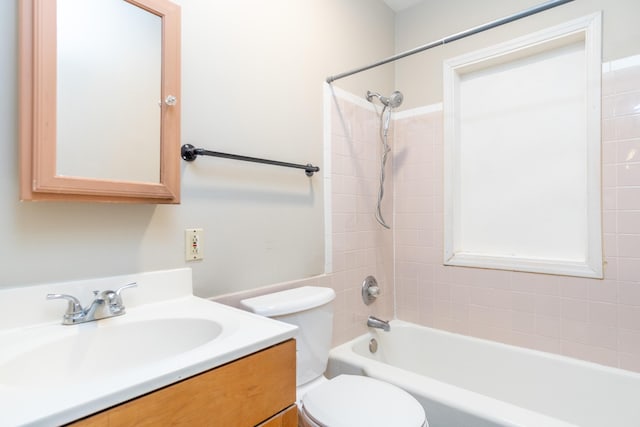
[443,12,603,278]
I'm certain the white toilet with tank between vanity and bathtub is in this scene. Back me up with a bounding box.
[241,286,428,427]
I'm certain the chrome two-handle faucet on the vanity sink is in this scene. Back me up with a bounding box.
[47,282,138,325]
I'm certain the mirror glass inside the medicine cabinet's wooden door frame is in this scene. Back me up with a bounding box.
[56,0,162,183]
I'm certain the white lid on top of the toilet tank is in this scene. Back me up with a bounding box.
[240,286,336,317]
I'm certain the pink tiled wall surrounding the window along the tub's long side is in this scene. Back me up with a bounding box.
[394,60,640,372]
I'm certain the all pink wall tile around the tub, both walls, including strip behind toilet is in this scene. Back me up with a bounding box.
[218,61,640,372]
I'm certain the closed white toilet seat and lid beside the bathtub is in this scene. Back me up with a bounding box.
[300,375,428,427]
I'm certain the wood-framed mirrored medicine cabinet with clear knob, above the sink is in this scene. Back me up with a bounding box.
[20,0,180,203]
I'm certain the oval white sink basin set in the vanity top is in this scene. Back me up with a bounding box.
[0,318,222,387]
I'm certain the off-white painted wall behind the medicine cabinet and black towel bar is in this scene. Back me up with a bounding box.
[0,0,394,296]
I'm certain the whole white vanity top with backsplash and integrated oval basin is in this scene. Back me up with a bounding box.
[0,269,296,427]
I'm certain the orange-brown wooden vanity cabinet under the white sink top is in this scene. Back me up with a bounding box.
[69,340,298,427]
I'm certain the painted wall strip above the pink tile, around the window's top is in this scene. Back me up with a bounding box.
[395,0,640,109]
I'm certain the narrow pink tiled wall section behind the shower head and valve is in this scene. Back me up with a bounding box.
[325,92,394,344]
